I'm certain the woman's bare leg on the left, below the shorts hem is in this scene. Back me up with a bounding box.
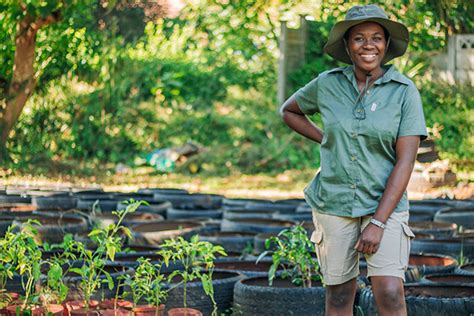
[326,278,357,316]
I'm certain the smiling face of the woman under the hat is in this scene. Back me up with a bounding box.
[347,22,387,72]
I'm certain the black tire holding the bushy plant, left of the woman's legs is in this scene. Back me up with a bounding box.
[234,277,326,316]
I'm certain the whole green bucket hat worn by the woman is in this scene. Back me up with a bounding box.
[324,4,409,64]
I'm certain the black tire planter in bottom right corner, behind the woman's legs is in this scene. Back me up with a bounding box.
[359,284,474,316]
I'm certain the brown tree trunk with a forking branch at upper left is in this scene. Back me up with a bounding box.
[0,14,59,160]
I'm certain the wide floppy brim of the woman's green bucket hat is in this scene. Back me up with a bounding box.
[324,17,410,64]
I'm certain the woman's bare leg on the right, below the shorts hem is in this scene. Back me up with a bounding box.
[370,276,407,316]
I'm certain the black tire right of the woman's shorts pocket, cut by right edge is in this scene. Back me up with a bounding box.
[410,237,474,260]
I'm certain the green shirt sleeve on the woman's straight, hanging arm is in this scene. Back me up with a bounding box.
[398,85,428,140]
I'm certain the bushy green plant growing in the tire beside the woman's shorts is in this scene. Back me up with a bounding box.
[257,225,322,288]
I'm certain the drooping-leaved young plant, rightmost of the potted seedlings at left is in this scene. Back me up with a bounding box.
[158,235,227,315]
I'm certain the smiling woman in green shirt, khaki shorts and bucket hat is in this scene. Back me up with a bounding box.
[281,5,427,315]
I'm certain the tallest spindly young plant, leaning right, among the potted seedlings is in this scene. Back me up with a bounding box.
[70,200,142,310]
